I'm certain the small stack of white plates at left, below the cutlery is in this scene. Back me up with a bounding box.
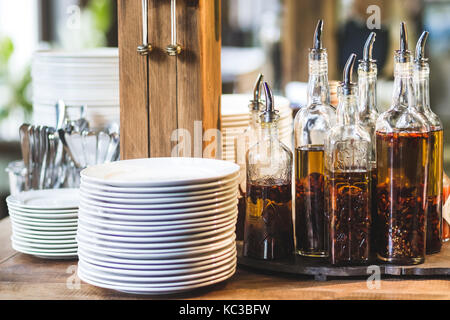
[6,189,78,259]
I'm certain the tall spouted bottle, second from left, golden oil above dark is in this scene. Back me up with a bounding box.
[294,20,336,257]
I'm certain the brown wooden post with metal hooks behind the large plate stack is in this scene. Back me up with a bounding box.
[118,0,222,160]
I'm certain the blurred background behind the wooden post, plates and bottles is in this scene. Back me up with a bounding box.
[0,0,450,218]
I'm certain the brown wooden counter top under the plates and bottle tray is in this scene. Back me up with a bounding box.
[0,218,450,300]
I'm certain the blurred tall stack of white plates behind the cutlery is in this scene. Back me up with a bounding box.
[32,48,120,127]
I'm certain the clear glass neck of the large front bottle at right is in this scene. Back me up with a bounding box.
[392,61,416,108]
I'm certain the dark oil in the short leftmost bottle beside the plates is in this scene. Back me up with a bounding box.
[244,182,294,260]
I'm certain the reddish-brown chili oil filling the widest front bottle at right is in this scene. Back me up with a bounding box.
[375,132,429,264]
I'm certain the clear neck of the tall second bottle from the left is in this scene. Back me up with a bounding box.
[308,53,330,105]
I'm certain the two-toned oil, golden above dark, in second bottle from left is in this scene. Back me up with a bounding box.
[295,146,328,257]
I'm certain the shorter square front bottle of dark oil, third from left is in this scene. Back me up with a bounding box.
[325,54,373,265]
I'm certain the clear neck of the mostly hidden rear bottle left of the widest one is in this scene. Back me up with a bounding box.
[358,62,378,114]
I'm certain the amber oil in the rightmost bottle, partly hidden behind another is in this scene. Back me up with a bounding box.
[426,130,444,254]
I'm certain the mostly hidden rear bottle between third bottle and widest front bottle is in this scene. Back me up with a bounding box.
[358,32,379,255]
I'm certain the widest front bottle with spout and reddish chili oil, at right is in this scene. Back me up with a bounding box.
[375,23,430,264]
